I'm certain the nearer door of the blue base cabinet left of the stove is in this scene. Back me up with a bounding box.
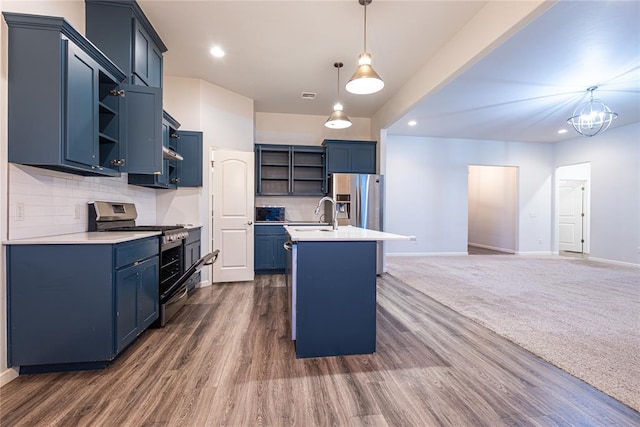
[116,265,139,353]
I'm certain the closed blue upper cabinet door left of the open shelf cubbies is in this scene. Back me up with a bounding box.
[65,41,99,168]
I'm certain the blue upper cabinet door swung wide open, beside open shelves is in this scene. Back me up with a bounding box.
[120,84,163,174]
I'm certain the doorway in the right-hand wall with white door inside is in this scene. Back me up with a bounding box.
[555,163,591,256]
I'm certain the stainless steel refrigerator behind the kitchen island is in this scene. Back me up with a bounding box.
[325,173,384,274]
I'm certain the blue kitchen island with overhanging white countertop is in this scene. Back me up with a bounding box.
[284,225,415,358]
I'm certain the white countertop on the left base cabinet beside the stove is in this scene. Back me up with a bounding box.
[2,231,160,245]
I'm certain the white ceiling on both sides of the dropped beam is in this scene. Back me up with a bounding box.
[139,0,640,142]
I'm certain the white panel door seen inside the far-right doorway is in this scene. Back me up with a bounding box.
[558,179,586,253]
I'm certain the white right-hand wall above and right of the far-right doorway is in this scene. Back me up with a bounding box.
[554,123,640,264]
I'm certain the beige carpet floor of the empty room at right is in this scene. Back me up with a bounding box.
[387,255,640,410]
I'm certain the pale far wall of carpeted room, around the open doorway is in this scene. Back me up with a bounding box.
[385,135,553,255]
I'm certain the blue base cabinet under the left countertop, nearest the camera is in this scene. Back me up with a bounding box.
[7,237,159,373]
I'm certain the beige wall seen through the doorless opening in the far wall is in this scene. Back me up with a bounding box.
[468,165,518,253]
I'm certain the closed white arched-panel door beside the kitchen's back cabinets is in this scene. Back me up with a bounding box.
[211,150,255,282]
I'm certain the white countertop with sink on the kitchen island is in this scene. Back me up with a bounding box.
[284,225,416,242]
